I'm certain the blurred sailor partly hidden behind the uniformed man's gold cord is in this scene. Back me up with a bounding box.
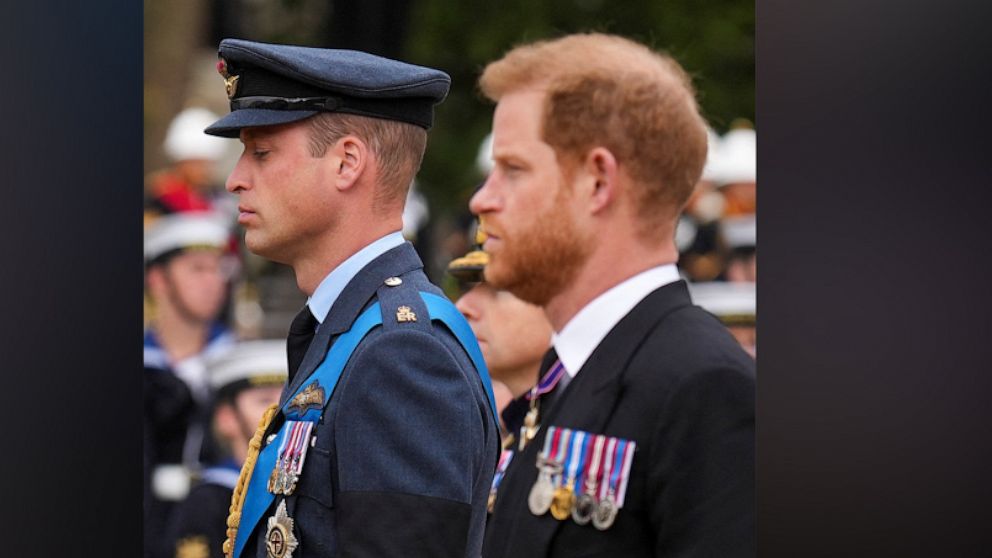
[169,340,286,558]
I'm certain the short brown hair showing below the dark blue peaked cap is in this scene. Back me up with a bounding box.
[309,112,427,212]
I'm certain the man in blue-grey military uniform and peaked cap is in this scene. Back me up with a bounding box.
[206,39,499,558]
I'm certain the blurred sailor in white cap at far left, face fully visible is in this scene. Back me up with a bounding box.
[143,212,234,558]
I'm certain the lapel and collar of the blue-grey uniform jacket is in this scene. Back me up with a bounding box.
[280,242,424,403]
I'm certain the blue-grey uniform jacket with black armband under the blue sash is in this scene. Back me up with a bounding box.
[242,243,499,558]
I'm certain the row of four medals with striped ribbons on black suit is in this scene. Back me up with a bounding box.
[527,426,635,531]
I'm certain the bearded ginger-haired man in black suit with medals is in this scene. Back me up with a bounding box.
[471,34,755,558]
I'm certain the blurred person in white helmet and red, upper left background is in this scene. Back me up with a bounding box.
[145,107,228,222]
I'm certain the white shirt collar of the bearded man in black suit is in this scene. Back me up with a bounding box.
[551,264,681,377]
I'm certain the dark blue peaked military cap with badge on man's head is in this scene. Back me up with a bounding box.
[204,39,451,138]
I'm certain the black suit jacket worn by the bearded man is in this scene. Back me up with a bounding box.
[483,281,755,558]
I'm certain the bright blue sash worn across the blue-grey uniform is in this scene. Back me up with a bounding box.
[233,292,499,558]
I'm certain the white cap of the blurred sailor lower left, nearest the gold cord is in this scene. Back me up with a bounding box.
[207,339,288,391]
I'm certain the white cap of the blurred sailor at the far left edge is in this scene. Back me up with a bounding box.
[145,211,229,262]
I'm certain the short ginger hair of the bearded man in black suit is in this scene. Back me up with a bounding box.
[479,33,706,235]
